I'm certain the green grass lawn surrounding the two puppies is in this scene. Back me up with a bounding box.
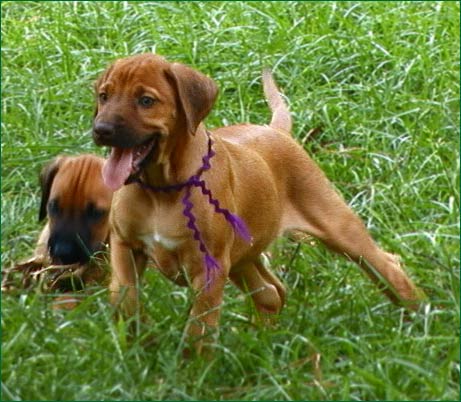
[1,2,460,400]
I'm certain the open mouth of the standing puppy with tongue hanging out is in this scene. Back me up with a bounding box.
[102,135,159,191]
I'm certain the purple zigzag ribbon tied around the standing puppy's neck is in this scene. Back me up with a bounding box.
[133,131,252,286]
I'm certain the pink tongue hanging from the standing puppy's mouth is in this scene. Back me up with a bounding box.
[102,147,133,191]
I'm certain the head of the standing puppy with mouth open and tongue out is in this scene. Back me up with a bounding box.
[93,54,218,190]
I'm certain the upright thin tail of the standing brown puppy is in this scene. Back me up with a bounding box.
[263,68,292,134]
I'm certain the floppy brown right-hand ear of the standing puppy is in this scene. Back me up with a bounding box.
[170,63,218,135]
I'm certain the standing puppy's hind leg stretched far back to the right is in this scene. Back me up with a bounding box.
[285,160,423,309]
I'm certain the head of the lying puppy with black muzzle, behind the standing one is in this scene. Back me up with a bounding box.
[39,155,112,265]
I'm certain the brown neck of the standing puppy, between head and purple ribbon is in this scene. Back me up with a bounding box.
[142,124,208,186]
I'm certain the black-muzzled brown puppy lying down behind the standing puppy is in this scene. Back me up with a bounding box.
[11,154,112,298]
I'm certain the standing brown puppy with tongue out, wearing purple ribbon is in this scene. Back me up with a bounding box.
[93,54,420,352]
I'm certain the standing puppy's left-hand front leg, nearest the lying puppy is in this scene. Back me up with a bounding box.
[109,234,147,317]
